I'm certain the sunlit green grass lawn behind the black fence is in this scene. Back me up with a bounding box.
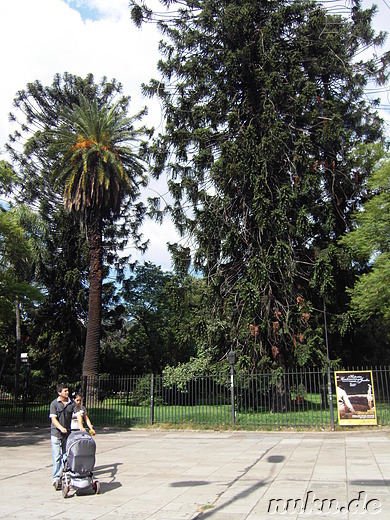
[0,394,390,430]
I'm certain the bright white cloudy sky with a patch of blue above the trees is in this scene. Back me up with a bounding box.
[0,0,390,270]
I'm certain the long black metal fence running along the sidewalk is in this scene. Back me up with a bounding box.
[0,367,390,430]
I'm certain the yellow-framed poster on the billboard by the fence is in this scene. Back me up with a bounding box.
[335,370,377,426]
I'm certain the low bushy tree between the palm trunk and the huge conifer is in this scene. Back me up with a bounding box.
[101,262,228,375]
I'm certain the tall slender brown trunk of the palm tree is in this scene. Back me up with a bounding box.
[83,213,103,402]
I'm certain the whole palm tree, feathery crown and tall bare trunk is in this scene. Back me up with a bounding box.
[48,95,146,384]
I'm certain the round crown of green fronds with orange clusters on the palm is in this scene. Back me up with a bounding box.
[50,95,145,215]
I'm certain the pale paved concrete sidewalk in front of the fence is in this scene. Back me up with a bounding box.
[0,428,390,520]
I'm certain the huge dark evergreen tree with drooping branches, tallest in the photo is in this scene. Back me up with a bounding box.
[131,0,389,368]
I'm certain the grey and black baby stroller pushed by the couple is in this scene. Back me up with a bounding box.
[61,431,100,498]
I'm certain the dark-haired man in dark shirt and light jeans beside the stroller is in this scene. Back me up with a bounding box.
[49,385,85,490]
